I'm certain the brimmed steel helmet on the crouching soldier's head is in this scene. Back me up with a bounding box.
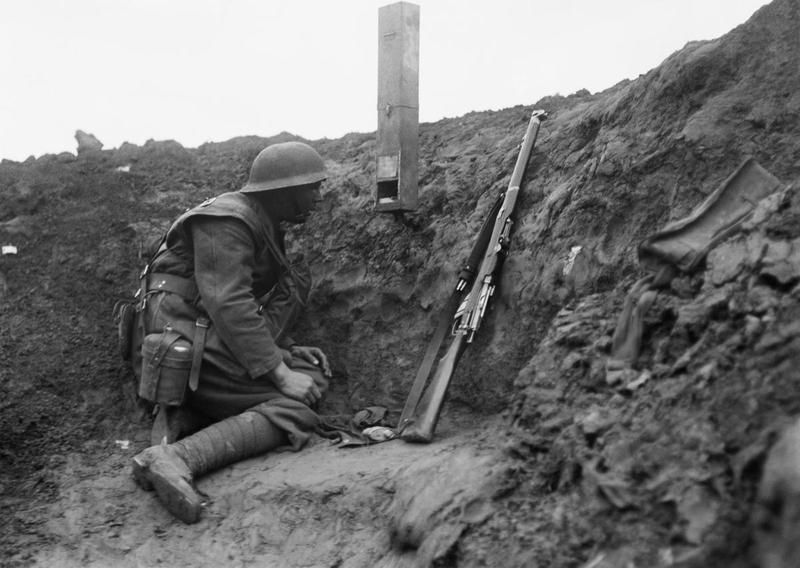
[241,142,327,193]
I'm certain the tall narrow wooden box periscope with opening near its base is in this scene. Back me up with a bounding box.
[375,2,419,211]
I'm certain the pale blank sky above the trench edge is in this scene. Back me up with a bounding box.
[0,0,767,161]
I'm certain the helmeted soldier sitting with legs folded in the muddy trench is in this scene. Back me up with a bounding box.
[133,142,331,523]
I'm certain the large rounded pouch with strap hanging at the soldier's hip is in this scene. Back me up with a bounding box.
[139,327,196,406]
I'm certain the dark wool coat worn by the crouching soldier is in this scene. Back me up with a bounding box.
[145,192,328,447]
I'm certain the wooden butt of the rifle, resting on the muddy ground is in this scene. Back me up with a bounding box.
[400,334,466,444]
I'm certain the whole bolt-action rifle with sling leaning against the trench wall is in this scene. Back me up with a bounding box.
[396,110,547,443]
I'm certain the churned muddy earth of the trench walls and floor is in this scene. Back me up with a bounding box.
[0,0,800,568]
